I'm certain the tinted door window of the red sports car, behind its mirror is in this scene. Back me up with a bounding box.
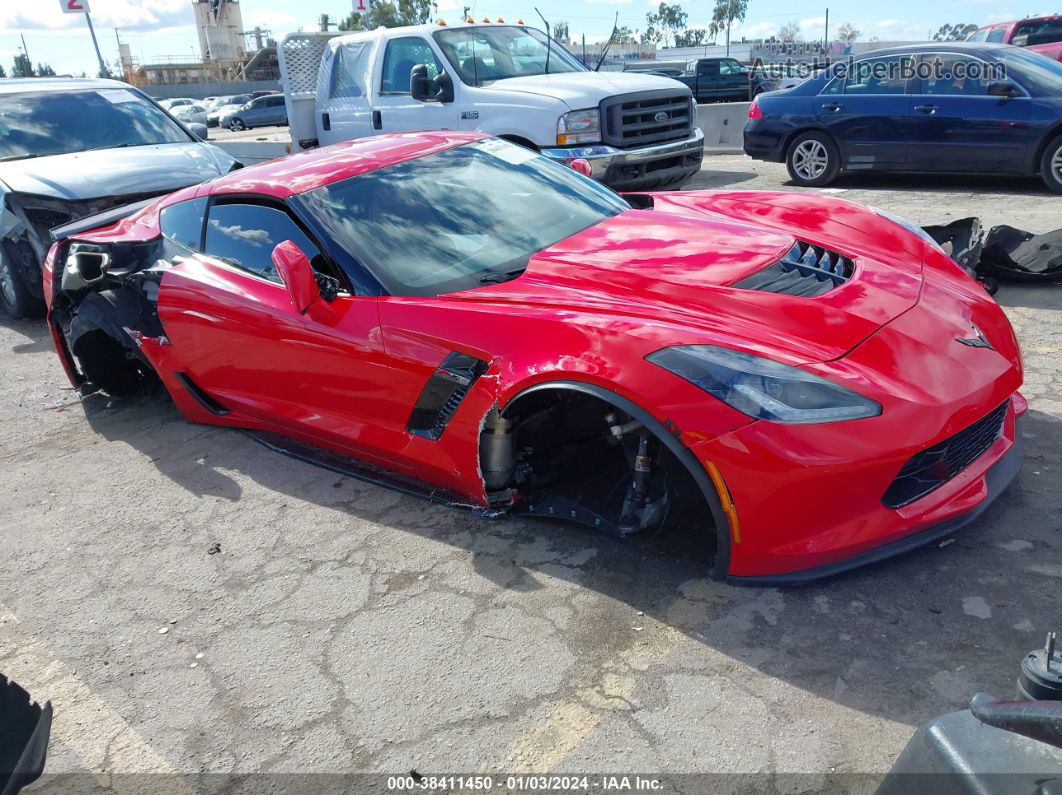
[203,204,321,284]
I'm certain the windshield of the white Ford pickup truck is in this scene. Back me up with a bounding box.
[434,25,587,86]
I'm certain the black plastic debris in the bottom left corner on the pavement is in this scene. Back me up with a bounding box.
[0,674,52,795]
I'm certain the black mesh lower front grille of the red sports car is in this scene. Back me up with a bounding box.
[881,400,1010,508]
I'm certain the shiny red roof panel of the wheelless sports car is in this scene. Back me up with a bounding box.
[200,131,487,198]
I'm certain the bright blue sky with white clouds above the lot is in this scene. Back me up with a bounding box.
[0,0,1054,74]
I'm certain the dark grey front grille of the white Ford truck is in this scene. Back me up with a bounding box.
[601,89,693,149]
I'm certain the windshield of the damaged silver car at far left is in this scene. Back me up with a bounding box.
[0,88,190,160]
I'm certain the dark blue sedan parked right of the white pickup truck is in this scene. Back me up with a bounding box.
[744,42,1062,192]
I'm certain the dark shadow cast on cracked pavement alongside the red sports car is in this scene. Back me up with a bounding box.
[76,382,1062,725]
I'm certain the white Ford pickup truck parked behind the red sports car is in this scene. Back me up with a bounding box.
[279,20,704,190]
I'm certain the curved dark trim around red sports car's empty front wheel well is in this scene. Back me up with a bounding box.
[498,380,731,580]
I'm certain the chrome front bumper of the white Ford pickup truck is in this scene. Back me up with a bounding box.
[542,127,704,190]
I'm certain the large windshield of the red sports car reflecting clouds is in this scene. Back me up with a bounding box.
[298,139,630,295]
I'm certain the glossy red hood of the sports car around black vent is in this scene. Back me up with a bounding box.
[450,209,922,364]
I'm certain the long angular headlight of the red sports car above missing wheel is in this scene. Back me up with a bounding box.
[646,345,881,424]
